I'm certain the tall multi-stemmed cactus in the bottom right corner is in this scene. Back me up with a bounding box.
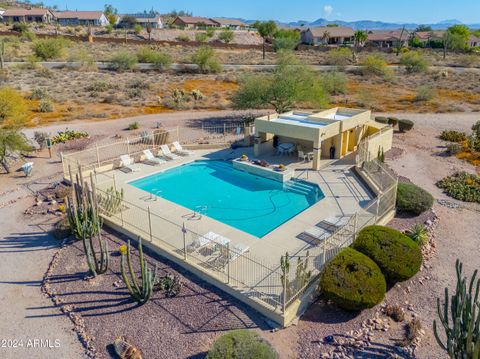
[433,259,480,359]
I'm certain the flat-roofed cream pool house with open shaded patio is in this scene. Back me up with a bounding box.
[254,108,392,170]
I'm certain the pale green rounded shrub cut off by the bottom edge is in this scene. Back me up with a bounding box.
[207,329,278,359]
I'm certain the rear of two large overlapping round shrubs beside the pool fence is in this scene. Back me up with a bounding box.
[353,226,422,284]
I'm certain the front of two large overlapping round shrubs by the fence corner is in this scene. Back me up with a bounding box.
[319,248,387,311]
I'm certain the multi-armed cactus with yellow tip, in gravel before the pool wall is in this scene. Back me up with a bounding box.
[120,238,157,305]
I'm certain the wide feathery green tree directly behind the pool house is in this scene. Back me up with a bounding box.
[232,52,327,113]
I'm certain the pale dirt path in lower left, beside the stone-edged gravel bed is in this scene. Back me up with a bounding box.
[0,187,83,359]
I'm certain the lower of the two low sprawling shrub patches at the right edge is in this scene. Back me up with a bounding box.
[437,172,480,203]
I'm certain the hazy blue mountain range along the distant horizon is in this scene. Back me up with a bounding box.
[241,18,480,30]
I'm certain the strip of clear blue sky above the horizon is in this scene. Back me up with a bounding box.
[44,0,480,23]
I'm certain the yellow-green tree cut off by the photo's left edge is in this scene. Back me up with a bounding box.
[0,87,31,173]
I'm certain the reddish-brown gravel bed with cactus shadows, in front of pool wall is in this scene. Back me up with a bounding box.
[48,230,268,358]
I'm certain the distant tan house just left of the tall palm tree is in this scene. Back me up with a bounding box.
[301,26,354,46]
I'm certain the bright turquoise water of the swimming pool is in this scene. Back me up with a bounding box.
[130,161,324,237]
